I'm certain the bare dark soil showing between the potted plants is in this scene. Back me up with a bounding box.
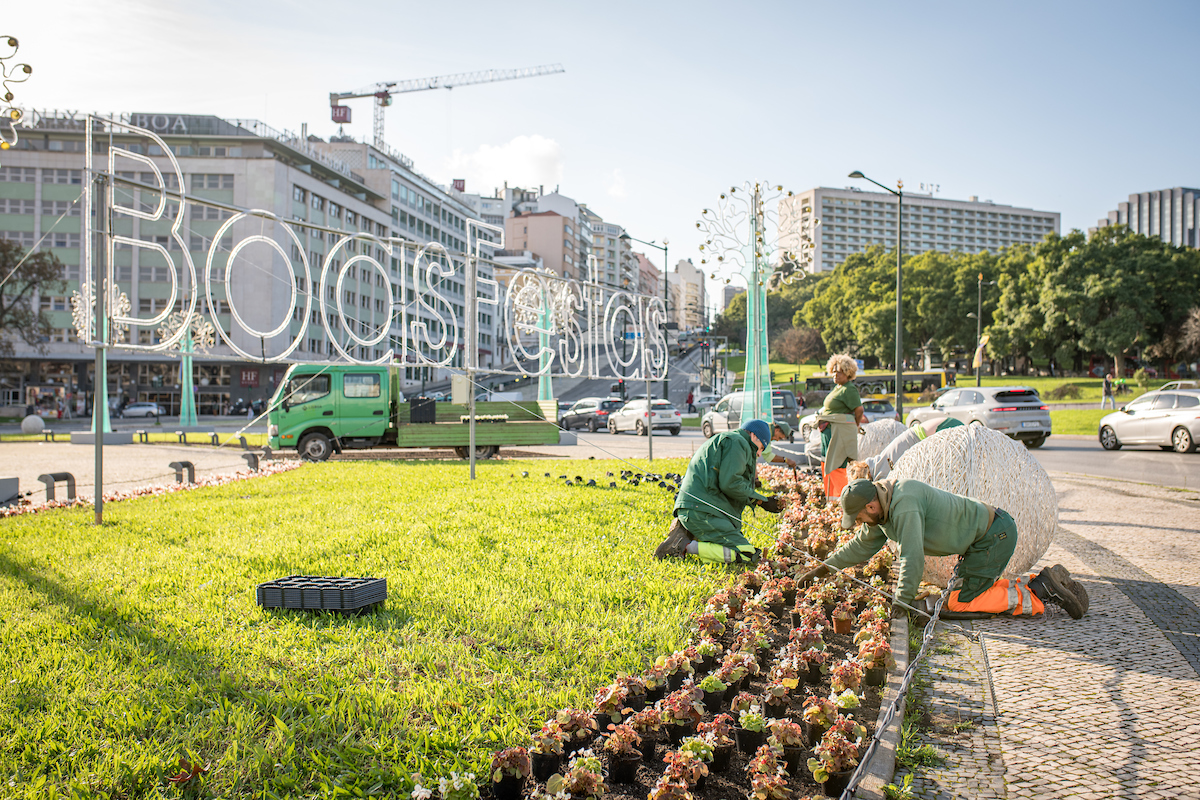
[513,613,883,800]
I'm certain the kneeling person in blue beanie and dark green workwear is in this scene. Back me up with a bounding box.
[654,420,782,564]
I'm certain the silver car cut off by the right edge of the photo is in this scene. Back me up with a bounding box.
[1099,389,1200,453]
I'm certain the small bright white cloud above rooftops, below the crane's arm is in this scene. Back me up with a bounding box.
[446,134,563,194]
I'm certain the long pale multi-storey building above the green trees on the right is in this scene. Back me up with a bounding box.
[779,187,1061,272]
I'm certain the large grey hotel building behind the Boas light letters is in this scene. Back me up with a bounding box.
[0,112,496,414]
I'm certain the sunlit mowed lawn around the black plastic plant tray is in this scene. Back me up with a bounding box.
[0,461,739,798]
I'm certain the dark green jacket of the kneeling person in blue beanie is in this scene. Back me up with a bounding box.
[674,429,767,530]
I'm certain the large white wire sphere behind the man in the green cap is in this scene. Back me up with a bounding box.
[890,425,1058,589]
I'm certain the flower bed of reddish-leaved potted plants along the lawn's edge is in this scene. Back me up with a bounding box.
[472,467,894,800]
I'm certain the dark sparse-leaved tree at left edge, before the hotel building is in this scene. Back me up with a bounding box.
[0,239,65,355]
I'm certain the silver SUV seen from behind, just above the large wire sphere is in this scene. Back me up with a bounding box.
[907,386,1050,449]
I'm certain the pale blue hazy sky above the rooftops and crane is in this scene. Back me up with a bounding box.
[9,0,1200,304]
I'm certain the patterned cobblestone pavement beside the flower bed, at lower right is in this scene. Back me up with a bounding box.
[895,473,1200,799]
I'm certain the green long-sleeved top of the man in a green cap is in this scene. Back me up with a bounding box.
[826,480,991,603]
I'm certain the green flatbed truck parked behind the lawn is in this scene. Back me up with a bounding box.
[266,363,558,461]
